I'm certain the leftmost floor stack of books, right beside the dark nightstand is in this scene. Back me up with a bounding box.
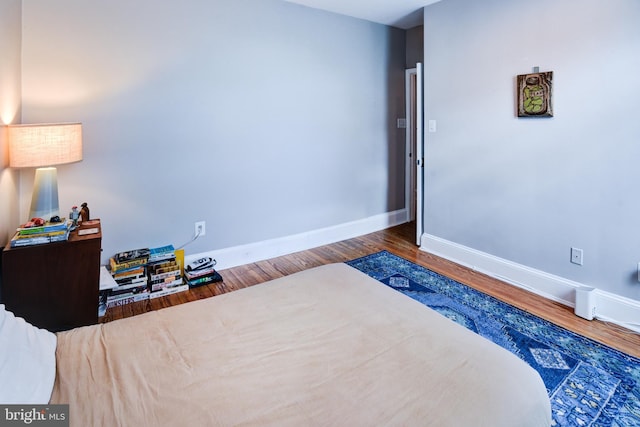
[106,248,149,308]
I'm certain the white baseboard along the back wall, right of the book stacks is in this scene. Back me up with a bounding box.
[185,209,407,270]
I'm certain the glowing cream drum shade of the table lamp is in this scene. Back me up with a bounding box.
[9,123,82,168]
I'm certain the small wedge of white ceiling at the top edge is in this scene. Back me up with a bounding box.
[286,0,440,30]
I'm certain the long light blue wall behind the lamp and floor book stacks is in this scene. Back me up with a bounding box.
[22,0,404,262]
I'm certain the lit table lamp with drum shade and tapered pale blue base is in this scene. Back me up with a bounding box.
[9,123,82,221]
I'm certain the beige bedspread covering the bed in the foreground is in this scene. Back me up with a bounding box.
[51,264,550,427]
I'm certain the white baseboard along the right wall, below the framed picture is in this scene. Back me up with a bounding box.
[420,234,640,332]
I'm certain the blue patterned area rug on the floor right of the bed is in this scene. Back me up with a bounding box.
[347,251,640,427]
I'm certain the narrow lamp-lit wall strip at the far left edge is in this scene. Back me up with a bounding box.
[0,0,22,246]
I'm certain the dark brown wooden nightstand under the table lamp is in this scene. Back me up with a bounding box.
[0,220,102,332]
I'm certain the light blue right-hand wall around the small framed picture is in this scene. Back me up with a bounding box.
[424,0,640,299]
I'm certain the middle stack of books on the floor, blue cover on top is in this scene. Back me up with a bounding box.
[147,245,189,298]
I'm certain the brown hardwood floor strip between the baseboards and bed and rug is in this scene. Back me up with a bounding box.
[101,224,640,357]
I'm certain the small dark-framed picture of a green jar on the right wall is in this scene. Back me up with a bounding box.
[517,71,553,117]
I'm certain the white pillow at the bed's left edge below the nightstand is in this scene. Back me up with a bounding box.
[0,304,57,405]
